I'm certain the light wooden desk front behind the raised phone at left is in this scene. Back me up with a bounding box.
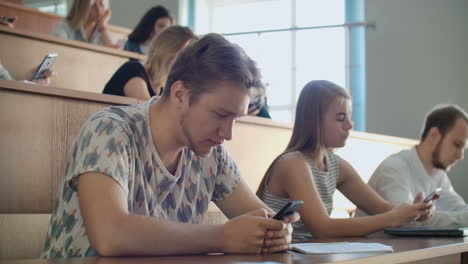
[0,27,145,93]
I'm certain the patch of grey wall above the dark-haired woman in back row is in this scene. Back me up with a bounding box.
[109,0,179,29]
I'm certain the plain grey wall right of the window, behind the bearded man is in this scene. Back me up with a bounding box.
[365,0,468,200]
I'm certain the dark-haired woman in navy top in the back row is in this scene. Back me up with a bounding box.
[124,5,174,55]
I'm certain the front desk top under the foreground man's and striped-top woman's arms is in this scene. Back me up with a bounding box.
[0,235,468,264]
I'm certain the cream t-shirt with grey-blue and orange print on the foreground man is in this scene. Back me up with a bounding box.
[41,97,239,258]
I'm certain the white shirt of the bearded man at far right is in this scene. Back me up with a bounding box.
[358,147,468,227]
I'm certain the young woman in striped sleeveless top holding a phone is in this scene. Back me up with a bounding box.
[257,81,432,242]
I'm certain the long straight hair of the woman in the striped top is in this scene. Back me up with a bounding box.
[257,80,351,197]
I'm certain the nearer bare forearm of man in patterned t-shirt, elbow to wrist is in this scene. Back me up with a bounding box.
[90,215,223,256]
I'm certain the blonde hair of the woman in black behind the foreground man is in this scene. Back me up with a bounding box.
[145,26,198,94]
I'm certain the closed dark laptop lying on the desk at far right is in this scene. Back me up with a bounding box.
[384,227,468,237]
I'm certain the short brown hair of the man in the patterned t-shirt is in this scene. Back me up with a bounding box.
[162,33,265,104]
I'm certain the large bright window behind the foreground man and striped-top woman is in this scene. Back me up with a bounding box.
[194,0,349,122]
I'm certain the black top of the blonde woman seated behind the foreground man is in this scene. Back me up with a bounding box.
[102,60,155,97]
